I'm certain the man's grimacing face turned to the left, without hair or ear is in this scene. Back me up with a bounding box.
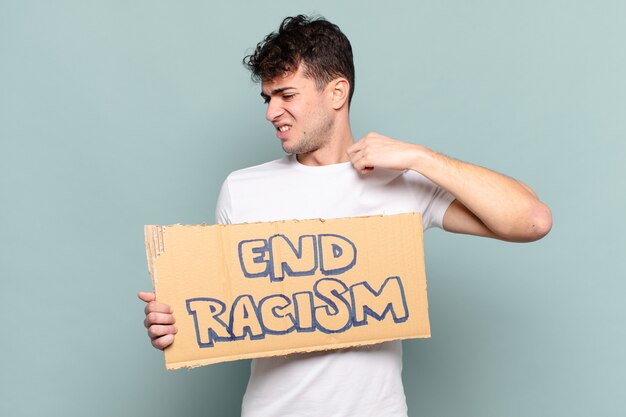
[261,65,335,154]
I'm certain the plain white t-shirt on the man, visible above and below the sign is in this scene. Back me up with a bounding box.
[215,155,454,417]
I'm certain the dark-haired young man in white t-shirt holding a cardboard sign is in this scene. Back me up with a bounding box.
[139,16,552,417]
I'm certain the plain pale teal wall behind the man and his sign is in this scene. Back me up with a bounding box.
[0,0,626,417]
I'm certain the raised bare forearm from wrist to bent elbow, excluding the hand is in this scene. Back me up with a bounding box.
[410,145,552,241]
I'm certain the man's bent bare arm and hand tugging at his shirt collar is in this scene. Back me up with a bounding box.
[348,133,552,242]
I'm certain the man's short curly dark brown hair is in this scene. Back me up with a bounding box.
[243,15,354,103]
